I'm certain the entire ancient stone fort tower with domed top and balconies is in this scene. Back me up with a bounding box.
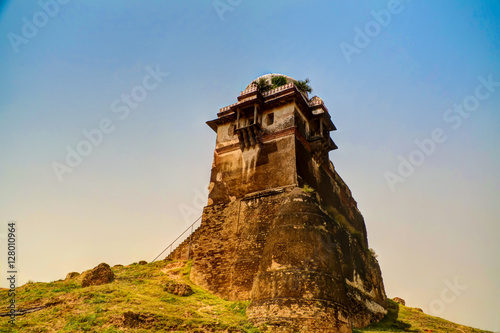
[168,74,387,333]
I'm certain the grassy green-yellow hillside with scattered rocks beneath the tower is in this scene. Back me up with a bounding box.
[0,261,487,333]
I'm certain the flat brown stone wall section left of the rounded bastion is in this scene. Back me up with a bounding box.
[167,188,289,300]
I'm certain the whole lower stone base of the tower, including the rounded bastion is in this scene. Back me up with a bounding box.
[169,186,387,333]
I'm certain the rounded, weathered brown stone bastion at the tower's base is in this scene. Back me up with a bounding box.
[248,188,386,332]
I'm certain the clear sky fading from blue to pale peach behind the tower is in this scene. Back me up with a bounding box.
[0,0,500,331]
